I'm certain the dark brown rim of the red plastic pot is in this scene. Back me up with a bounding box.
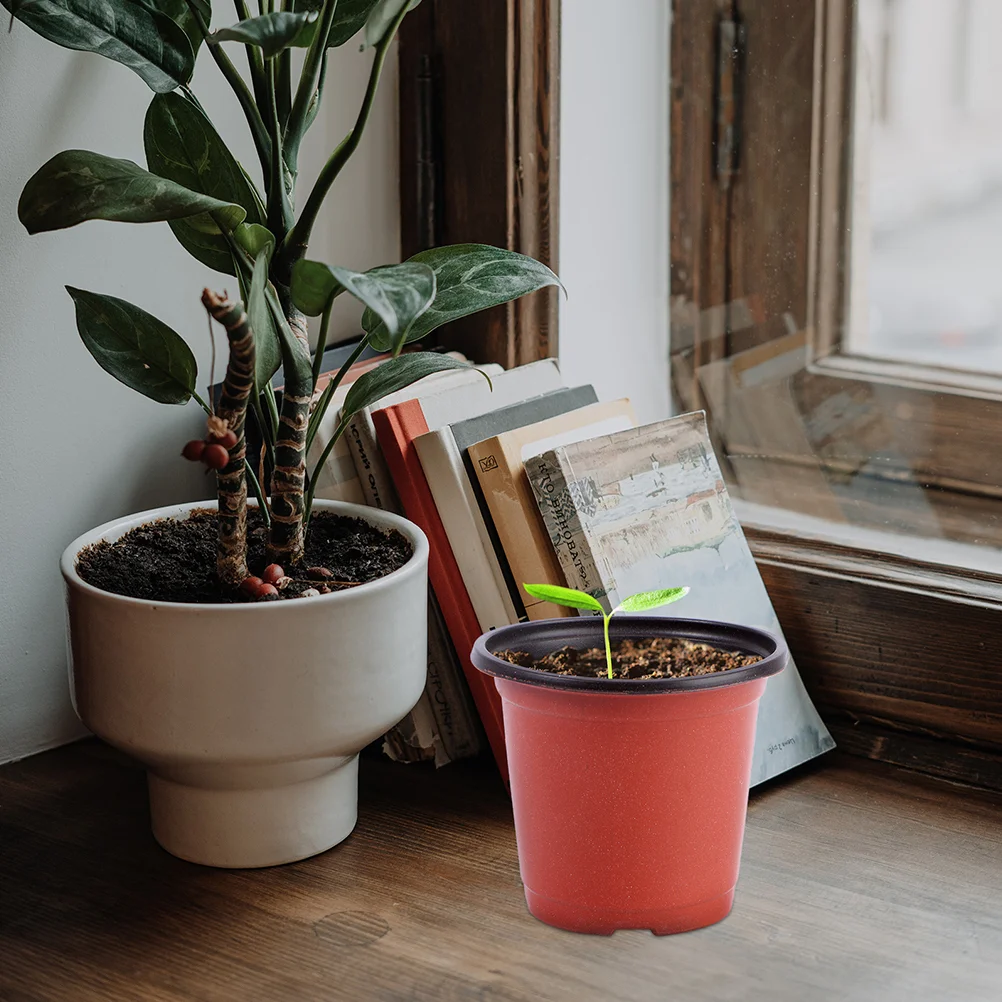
[470,616,789,695]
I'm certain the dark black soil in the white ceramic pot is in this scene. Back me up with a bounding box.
[76,508,412,603]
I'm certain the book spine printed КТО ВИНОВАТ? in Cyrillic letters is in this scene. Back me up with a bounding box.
[525,450,609,606]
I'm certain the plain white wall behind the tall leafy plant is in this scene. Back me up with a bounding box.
[0,33,400,762]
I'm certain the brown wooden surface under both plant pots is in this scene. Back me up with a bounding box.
[0,742,1002,1002]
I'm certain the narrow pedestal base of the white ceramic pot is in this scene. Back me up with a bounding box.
[148,756,359,869]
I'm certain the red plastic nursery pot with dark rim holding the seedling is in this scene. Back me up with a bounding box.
[472,616,787,935]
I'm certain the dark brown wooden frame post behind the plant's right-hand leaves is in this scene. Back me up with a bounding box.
[400,0,560,367]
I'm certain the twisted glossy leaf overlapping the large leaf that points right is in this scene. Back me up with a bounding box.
[290,259,435,340]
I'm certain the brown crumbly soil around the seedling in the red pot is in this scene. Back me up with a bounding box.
[497,637,761,678]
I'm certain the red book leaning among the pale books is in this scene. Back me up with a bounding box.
[372,400,508,786]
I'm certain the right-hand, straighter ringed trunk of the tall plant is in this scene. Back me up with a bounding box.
[268,310,313,568]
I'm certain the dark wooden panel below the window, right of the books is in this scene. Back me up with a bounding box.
[745,528,1002,753]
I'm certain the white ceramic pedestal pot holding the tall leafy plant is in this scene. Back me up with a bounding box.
[62,501,428,867]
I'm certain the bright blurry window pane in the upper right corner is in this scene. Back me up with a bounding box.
[844,0,1002,374]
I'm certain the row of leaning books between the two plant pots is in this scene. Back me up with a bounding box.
[302,348,833,783]
